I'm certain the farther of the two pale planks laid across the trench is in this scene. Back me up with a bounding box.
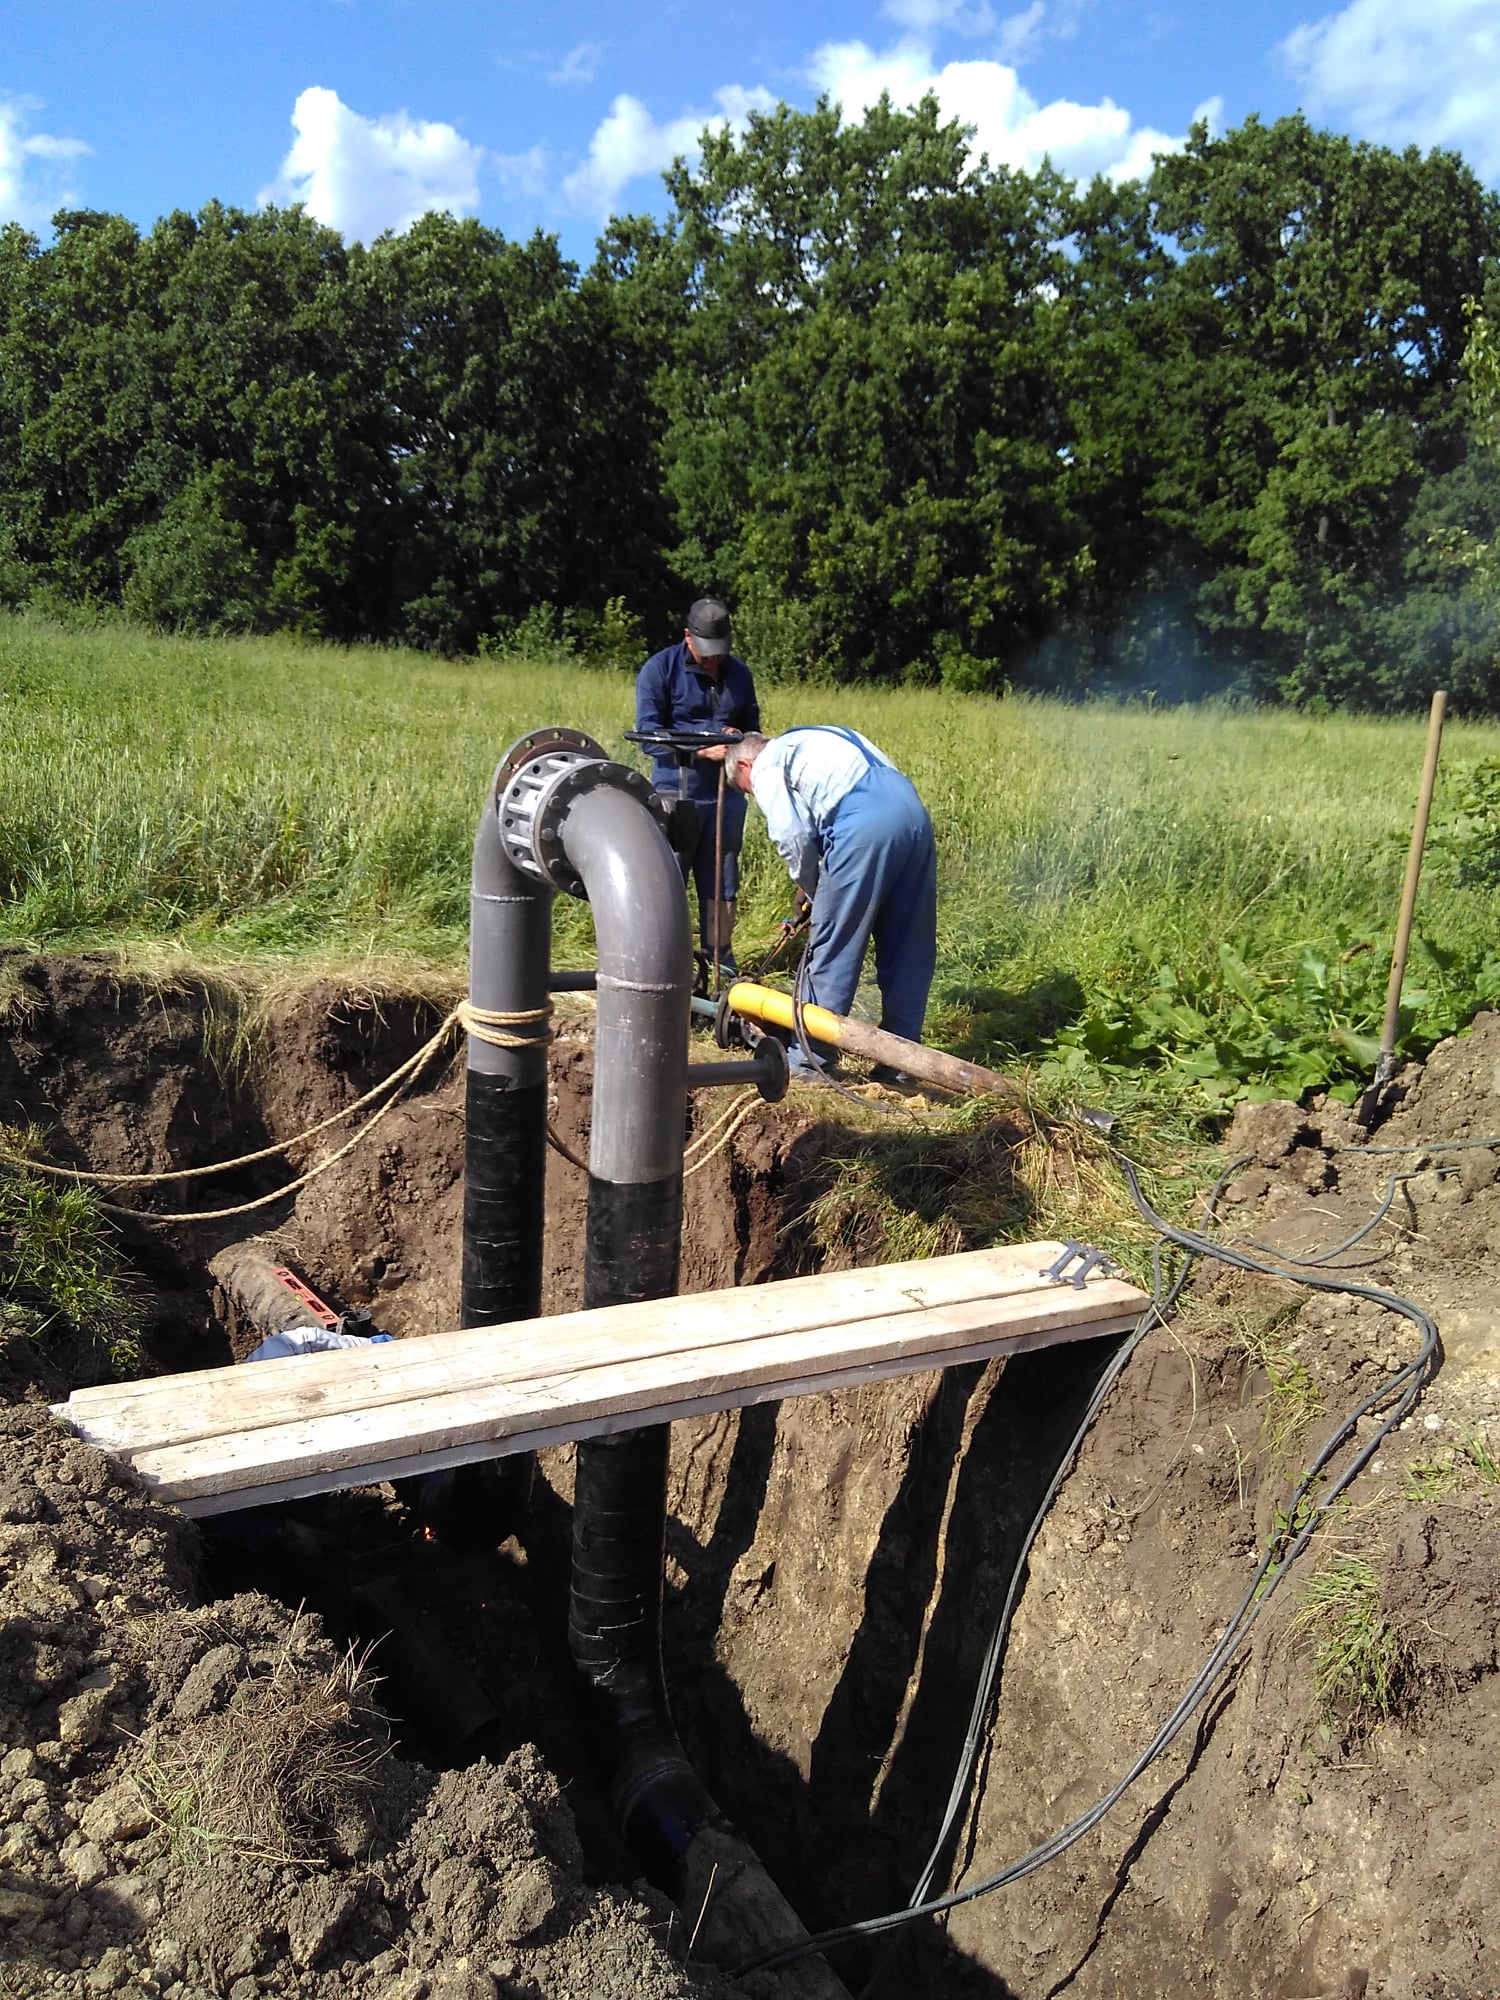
[64,1242,1140,1450]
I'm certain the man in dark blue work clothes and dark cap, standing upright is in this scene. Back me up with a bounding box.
[636,598,760,974]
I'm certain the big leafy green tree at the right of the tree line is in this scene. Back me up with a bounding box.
[1142,118,1500,704]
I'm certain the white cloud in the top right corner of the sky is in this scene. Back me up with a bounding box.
[1282,0,1500,180]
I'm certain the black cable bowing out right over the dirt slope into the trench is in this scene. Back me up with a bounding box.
[740,1154,1440,1976]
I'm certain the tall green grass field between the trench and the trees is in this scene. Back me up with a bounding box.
[0,618,1500,1098]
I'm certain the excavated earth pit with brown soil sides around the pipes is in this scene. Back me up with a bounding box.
[0,960,1500,2000]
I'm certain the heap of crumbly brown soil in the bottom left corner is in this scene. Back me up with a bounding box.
[0,1408,744,2000]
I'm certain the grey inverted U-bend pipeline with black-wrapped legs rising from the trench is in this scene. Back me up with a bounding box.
[440,728,844,2000]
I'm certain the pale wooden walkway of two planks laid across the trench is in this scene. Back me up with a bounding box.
[58,1242,1146,1512]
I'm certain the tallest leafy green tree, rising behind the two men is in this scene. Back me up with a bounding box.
[624,100,1080,686]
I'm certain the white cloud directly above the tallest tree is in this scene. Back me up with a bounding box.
[810,36,1214,180]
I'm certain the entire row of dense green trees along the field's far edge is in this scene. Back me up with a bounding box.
[0,100,1500,708]
